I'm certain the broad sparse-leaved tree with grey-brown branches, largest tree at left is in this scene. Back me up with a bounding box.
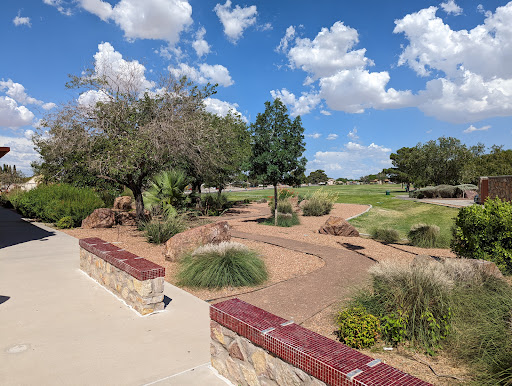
[33,66,217,219]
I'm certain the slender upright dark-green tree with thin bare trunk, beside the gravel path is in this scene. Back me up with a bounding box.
[250,98,307,223]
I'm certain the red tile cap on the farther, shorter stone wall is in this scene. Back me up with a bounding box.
[78,237,165,280]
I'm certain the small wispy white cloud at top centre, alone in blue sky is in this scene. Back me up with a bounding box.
[213,0,258,44]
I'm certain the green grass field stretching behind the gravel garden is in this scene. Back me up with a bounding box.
[226,185,458,248]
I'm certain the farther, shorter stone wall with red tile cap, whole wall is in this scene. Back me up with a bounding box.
[79,237,165,315]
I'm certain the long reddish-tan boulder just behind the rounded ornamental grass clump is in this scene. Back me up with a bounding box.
[164,221,231,261]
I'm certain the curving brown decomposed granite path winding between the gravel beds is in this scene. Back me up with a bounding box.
[226,230,374,323]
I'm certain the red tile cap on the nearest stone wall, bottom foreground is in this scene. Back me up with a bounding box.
[210,298,430,386]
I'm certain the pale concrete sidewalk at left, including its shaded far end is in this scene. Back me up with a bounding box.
[0,208,225,385]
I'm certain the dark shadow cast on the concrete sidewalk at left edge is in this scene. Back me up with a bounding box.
[0,208,55,249]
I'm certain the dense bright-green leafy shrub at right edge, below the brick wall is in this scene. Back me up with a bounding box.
[451,198,512,274]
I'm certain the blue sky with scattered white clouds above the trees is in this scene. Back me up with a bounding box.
[0,0,512,178]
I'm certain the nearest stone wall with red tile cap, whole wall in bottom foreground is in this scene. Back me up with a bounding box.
[210,299,429,386]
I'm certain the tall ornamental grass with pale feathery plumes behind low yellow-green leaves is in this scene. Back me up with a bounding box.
[363,262,453,353]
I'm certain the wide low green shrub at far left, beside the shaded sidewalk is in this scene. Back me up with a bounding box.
[11,184,104,226]
